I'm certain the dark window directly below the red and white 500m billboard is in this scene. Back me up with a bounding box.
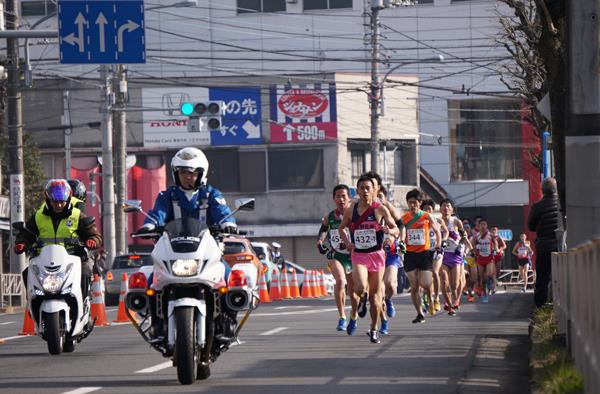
[269,149,323,190]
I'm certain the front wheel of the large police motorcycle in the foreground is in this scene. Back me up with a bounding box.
[175,306,196,384]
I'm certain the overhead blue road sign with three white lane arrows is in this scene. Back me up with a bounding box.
[58,0,146,64]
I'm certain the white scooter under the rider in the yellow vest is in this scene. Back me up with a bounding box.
[13,222,94,355]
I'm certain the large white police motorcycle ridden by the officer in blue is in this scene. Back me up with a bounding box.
[123,198,259,384]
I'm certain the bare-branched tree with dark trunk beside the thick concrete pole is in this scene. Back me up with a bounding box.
[498,0,567,207]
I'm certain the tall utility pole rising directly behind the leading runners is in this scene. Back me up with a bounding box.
[369,1,383,172]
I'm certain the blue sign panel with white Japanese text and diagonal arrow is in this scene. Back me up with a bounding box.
[208,87,263,145]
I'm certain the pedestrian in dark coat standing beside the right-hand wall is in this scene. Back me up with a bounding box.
[528,178,562,308]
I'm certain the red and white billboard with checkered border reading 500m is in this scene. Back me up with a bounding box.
[270,83,337,143]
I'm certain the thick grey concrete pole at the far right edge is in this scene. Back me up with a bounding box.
[565,0,600,247]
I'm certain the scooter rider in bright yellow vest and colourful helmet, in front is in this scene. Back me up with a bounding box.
[14,179,102,299]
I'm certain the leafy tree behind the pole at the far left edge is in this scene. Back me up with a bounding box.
[0,133,46,218]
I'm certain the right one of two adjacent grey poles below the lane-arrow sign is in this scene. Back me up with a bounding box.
[113,64,127,255]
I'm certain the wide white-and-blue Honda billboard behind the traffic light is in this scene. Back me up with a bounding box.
[142,86,263,148]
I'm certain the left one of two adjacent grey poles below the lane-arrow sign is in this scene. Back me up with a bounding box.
[100,65,115,261]
